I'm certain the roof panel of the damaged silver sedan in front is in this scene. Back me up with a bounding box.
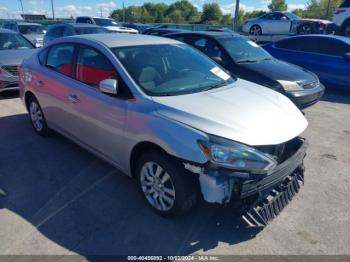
[69,33,179,48]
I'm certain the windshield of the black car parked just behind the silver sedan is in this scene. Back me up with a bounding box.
[218,37,273,63]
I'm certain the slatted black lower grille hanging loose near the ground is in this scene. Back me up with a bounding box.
[242,172,304,227]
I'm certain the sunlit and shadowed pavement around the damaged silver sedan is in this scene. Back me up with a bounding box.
[0,89,350,257]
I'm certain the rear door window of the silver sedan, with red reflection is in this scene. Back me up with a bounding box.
[46,44,74,77]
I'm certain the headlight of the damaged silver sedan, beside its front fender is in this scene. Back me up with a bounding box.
[198,136,277,173]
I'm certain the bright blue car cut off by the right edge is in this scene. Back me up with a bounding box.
[264,35,350,89]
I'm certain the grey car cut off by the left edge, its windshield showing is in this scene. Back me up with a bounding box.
[0,29,36,93]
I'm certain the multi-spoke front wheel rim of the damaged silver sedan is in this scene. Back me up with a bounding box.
[140,162,175,212]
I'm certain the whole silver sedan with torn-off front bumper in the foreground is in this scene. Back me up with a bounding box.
[20,34,307,226]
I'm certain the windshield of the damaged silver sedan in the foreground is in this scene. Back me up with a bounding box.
[112,44,233,96]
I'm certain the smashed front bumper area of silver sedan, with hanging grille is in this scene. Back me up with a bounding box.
[184,137,306,227]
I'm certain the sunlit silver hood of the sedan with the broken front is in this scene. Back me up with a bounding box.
[153,79,308,146]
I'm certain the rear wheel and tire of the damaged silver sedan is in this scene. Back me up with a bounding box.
[28,96,50,136]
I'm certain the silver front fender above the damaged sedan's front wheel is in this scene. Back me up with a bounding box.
[124,100,209,174]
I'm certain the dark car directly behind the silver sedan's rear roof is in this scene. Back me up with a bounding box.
[44,24,109,44]
